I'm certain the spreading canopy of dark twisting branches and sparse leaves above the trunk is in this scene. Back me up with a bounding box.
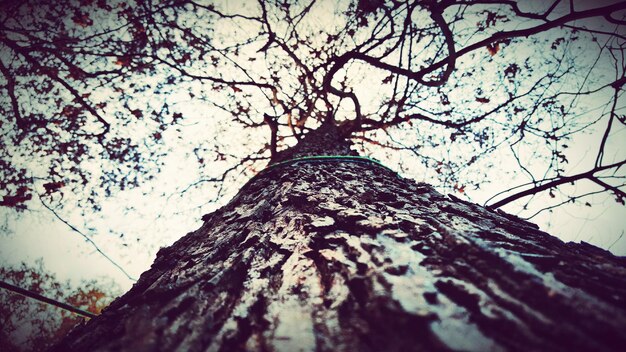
[0,0,626,250]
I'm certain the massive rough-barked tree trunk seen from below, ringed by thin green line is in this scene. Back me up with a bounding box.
[53,126,626,351]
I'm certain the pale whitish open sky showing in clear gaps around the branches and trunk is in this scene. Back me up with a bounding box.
[0,2,626,296]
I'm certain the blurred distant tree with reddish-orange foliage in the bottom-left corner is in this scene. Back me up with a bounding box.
[0,261,120,351]
